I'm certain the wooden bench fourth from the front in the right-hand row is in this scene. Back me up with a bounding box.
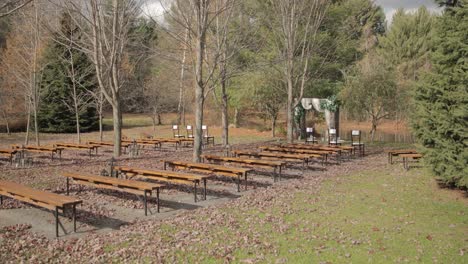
[164,161,252,192]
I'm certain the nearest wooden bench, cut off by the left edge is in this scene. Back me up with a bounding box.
[0,181,82,237]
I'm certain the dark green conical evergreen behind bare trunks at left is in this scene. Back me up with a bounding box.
[39,15,97,133]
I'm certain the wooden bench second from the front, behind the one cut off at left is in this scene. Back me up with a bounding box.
[62,172,164,215]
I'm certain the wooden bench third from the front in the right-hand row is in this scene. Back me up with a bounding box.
[114,166,211,202]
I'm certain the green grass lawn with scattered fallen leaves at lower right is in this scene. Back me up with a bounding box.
[159,165,468,263]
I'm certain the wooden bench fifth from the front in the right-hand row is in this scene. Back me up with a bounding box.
[201,155,286,182]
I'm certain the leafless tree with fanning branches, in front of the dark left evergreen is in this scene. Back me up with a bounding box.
[65,0,141,156]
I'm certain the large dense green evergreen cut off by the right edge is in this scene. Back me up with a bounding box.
[413,0,468,188]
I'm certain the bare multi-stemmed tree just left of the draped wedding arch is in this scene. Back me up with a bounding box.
[269,0,329,142]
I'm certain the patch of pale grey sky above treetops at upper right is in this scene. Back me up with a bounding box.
[375,0,441,24]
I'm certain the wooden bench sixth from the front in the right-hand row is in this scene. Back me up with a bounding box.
[232,150,325,167]
